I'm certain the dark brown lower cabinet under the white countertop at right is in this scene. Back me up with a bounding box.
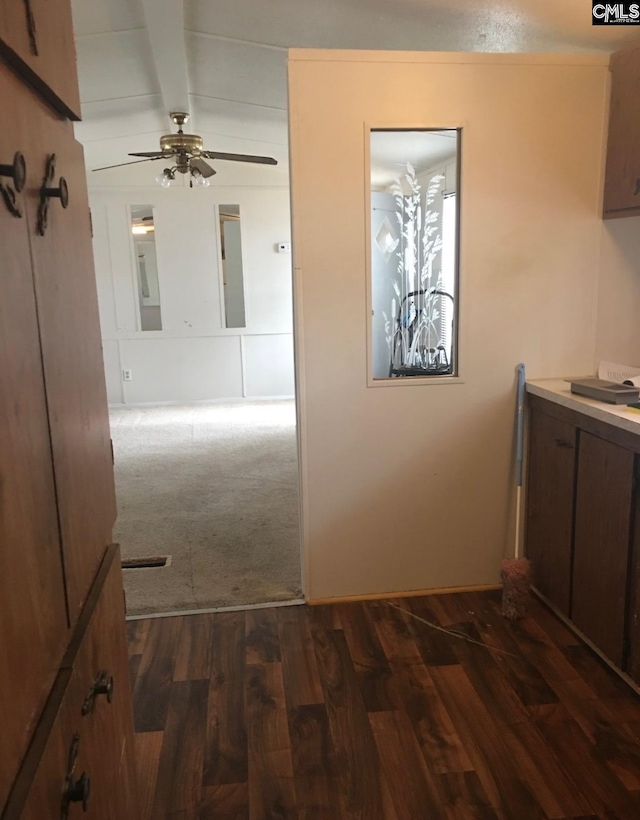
[525,395,640,683]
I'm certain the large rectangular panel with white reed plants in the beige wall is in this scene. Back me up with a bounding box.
[370,128,460,379]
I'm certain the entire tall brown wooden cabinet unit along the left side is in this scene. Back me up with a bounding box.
[0,0,138,820]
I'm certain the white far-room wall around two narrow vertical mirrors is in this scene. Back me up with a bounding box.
[89,185,294,404]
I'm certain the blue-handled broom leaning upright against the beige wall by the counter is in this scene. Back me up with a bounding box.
[500,364,531,621]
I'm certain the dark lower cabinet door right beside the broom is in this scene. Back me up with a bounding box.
[525,410,576,615]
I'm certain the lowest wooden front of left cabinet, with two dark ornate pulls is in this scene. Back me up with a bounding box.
[7,549,138,820]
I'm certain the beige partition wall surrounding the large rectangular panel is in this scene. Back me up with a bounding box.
[289,50,607,600]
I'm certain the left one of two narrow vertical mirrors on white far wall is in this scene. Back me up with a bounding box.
[131,205,162,330]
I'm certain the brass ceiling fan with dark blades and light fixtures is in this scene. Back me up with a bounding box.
[93,111,278,188]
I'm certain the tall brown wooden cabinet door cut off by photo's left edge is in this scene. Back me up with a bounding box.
[0,65,68,809]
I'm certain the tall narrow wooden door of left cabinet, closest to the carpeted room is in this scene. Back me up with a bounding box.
[22,99,116,622]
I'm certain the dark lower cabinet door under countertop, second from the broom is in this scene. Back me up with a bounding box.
[572,432,634,666]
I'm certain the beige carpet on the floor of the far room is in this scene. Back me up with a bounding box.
[111,400,301,615]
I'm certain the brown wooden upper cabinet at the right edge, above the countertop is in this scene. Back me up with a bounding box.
[604,45,640,219]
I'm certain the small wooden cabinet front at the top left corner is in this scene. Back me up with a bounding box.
[0,0,80,120]
